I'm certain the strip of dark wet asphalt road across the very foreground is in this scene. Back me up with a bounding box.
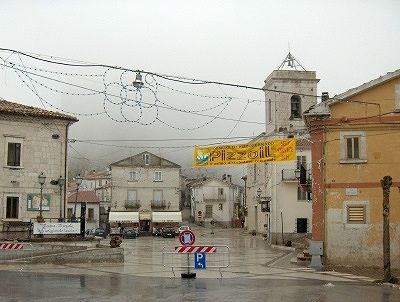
[0,271,400,302]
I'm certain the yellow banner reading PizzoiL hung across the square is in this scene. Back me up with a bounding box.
[193,138,296,167]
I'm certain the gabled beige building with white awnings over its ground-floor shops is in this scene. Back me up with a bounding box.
[110,152,182,231]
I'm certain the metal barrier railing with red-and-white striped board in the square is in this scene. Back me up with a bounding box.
[162,245,230,278]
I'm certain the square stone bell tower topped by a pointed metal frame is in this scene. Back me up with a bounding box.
[263,51,319,134]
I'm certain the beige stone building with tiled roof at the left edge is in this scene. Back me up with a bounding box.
[0,99,77,230]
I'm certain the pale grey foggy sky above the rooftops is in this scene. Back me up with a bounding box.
[0,0,400,183]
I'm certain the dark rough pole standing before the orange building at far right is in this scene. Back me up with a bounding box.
[381,176,392,282]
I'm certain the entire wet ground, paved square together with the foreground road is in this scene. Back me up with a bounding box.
[0,228,400,302]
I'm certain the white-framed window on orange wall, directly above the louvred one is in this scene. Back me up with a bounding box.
[340,131,367,164]
